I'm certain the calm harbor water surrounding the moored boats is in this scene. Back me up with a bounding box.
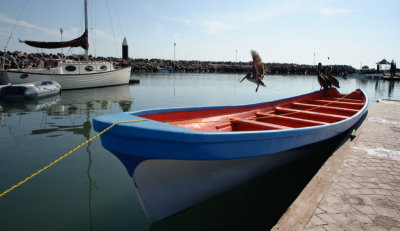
[0,73,400,230]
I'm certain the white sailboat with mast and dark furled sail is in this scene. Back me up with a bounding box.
[2,0,131,90]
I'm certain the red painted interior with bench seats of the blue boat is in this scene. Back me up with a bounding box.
[142,89,366,132]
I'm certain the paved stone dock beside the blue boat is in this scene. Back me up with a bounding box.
[272,100,400,231]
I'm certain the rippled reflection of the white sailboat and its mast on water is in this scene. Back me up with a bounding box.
[12,85,132,230]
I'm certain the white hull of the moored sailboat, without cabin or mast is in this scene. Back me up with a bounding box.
[3,67,131,90]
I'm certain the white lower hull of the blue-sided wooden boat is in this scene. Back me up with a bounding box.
[132,147,307,221]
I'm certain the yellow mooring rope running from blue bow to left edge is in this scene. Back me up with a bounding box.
[0,119,145,197]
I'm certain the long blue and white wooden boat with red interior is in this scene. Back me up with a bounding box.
[93,89,368,220]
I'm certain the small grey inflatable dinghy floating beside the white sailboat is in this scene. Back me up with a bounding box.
[0,80,61,100]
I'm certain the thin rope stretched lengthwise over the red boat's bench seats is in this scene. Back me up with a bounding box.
[167,93,351,125]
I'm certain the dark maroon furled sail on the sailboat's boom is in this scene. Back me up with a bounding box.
[22,30,89,50]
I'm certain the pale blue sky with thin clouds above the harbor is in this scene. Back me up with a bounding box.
[0,0,400,68]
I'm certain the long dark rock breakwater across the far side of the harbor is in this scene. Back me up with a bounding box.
[0,51,357,75]
